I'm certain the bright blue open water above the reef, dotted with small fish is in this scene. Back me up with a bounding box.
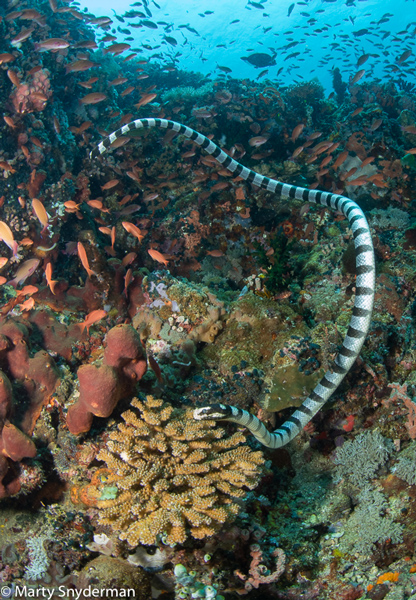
[79,0,416,90]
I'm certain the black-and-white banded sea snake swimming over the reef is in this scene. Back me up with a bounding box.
[90,119,375,448]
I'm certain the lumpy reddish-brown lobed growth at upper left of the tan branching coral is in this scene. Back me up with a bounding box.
[66,325,147,435]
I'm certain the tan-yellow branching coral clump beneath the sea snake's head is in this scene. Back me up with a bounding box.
[97,396,264,547]
